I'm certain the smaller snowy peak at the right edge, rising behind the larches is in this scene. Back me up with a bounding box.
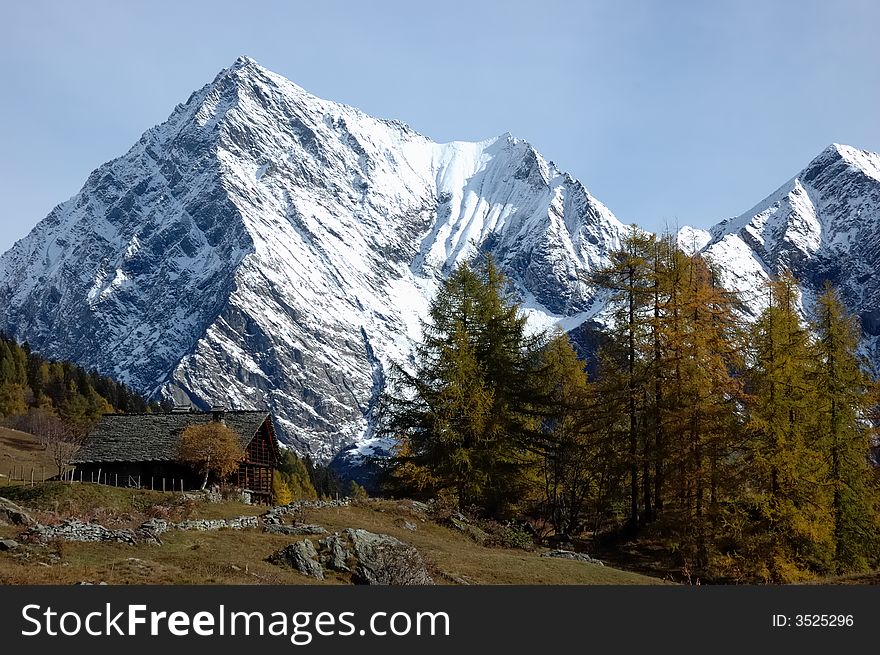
[702,144,880,364]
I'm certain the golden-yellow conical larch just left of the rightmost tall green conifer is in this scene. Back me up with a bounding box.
[746,272,831,582]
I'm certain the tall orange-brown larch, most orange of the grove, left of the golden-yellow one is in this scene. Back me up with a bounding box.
[660,251,742,571]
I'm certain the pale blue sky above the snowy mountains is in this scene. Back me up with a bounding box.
[0,0,880,251]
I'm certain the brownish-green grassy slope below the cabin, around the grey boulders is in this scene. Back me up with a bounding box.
[0,483,660,584]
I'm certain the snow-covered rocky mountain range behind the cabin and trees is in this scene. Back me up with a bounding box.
[0,57,880,461]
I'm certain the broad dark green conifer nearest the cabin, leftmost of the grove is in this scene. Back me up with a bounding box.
[381,257,540,517]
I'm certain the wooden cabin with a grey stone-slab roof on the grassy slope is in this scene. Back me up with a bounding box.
[72,407,280,503]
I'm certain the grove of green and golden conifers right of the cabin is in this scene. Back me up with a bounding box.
[380,237,878,582]
